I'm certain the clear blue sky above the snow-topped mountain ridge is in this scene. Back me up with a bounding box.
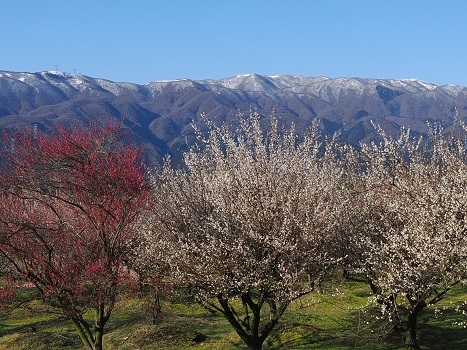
[0,0,467,86]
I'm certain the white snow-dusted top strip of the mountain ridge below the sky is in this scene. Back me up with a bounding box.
[0,71,465,103]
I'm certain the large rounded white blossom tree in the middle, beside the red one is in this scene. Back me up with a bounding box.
[139,114,341,349]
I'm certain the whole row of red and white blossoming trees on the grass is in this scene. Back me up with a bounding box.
[0,114,467,349]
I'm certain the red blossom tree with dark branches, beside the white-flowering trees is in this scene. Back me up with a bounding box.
[0,123,148,349]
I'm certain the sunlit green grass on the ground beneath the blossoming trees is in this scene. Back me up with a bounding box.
[0,281,467,350]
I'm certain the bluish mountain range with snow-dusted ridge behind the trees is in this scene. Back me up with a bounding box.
[0,71,467,162]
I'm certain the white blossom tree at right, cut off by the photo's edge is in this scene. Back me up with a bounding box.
[344,127,467,349]
